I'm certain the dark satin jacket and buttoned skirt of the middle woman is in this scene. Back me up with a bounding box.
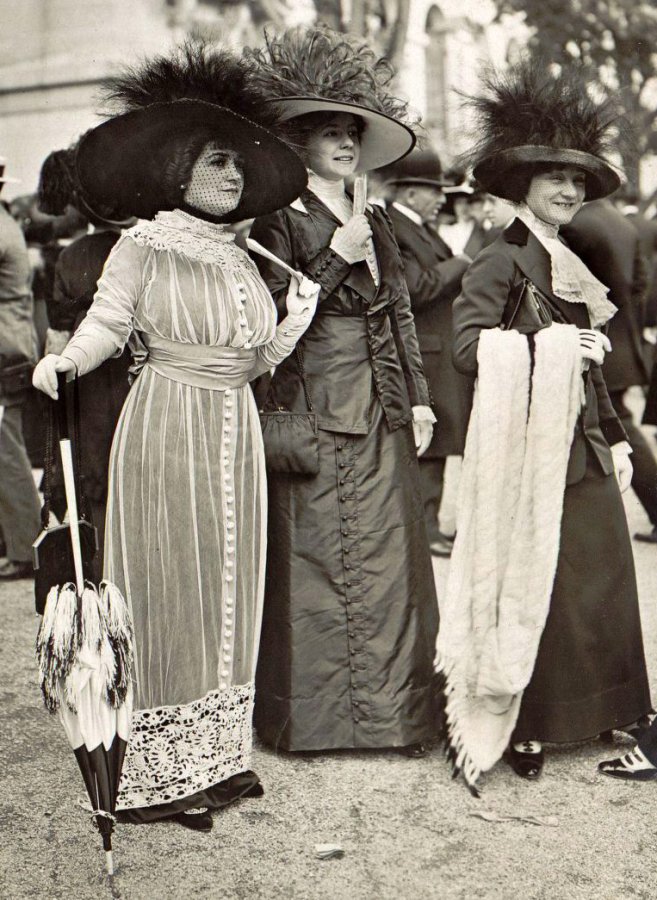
[251,191,438,750]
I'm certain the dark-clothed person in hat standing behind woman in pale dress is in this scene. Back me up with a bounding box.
[37,147,136,577]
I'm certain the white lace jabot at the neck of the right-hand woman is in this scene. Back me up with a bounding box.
[516,203,617,328]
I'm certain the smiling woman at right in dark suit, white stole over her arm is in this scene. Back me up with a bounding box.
[439,64,650,787]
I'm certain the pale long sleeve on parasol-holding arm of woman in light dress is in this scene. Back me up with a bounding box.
[62,236,149,375]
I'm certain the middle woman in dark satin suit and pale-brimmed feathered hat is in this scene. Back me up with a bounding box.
[246,29,438,755]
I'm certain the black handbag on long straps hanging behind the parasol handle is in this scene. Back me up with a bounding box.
[32,378,98,616]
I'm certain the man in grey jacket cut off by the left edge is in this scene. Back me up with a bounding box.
[0,157,39,581]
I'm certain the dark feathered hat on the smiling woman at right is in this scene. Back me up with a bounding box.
[466,59,620,200]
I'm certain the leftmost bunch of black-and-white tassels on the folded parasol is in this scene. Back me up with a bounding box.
[36,584,79,712]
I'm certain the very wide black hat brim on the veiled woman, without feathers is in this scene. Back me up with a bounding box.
[77,99,307,221]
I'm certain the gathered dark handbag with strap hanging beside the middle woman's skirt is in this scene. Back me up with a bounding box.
[260,347,319,475]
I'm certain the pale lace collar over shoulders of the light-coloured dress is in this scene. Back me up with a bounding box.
[126,211,258,275]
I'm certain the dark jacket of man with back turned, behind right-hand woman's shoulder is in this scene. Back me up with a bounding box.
[561,200,650,391]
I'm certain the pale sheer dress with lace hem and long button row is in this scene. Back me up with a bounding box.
[64,211,310,811]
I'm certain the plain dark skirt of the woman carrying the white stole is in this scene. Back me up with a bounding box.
[513,463,651,743]
